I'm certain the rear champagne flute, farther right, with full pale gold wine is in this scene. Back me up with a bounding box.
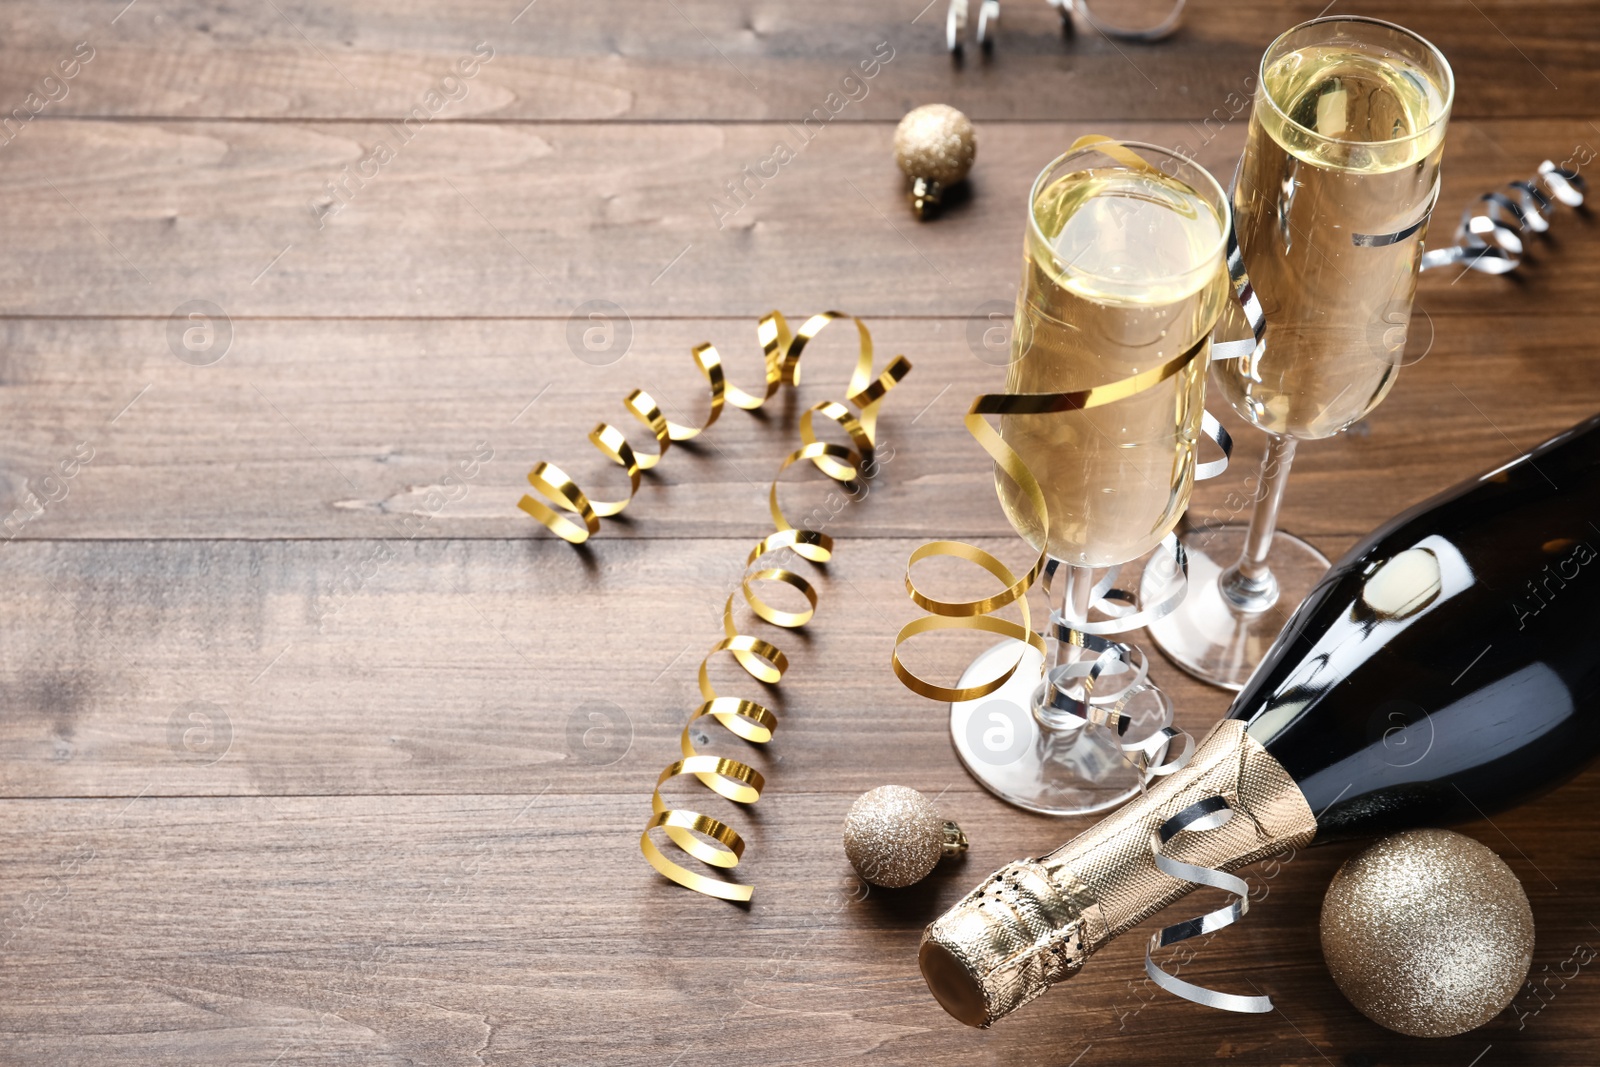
[1150,16,1454,689]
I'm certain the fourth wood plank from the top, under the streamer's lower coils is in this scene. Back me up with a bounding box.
[0,531,1226,793]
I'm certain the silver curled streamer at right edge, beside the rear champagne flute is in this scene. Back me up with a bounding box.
[1422,160,1589,274]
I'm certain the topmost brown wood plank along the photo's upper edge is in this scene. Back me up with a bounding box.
[0,0,1600,122]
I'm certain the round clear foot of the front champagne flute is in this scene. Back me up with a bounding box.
[950,641,1154,816]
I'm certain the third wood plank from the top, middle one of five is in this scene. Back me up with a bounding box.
[0,308,1600,549]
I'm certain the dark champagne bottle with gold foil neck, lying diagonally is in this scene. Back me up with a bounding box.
[920,416,1600,1027]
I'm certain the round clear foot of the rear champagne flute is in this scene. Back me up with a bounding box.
[1149,523,1331,691]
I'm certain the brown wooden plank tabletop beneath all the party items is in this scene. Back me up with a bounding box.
[0,0,1600,1067]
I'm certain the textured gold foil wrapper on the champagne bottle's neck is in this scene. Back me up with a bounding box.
[920,720,1317,1027]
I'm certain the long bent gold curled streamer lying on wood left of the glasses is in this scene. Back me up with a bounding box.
[624,312,910,901]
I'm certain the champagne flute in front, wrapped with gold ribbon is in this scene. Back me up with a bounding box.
[950,139,1232,814]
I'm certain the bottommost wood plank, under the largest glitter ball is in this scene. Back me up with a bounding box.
[0,790,1600,1067]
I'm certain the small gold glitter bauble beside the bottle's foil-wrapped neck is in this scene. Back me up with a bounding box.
[845,785,966,889]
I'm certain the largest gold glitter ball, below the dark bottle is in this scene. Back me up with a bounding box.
[1322,830,1533,1037]
